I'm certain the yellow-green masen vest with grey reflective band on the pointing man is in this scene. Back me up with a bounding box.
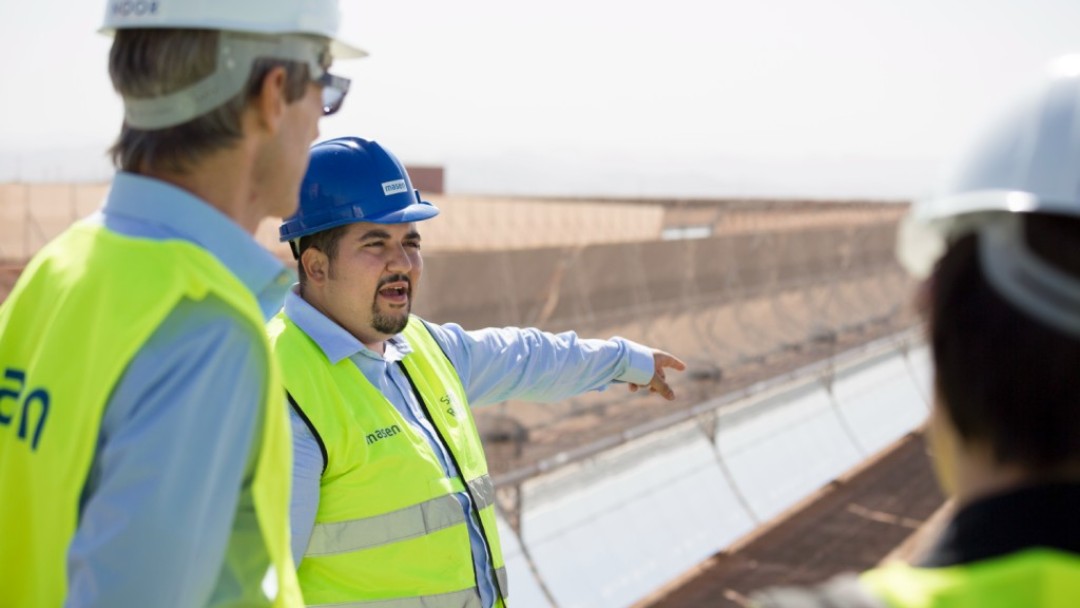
[269,313,508,608]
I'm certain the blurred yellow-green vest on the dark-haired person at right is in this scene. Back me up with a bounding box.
[859,548,1080,608]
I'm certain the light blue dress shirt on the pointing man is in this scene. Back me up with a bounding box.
[285,288,654,608]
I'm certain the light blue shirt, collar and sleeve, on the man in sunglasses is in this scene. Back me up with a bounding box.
[66,173,294,607]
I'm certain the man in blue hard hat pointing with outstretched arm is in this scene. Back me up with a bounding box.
[269,137,685,608]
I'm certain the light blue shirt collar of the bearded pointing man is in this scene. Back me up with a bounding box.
[285,285,413,365]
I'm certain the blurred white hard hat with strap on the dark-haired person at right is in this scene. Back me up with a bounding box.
[896,55,1080,336]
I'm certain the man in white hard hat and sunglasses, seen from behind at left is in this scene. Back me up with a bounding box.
[0,0,363,607]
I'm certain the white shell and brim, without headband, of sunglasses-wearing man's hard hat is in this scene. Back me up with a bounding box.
[100,0,367,58]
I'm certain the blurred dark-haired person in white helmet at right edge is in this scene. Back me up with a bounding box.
[755,56,1080,608]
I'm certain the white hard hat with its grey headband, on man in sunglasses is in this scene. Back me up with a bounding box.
[100,0,367,131]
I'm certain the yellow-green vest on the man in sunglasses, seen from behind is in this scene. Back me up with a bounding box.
[0,224,302,607]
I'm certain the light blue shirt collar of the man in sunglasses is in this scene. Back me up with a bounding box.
[103,172,293,319]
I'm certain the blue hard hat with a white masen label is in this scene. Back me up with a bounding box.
[280,137,438,242]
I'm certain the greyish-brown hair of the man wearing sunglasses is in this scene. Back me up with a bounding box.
[109,29,310,173]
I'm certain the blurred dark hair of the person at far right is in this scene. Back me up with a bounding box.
[928,214,1080,472]
